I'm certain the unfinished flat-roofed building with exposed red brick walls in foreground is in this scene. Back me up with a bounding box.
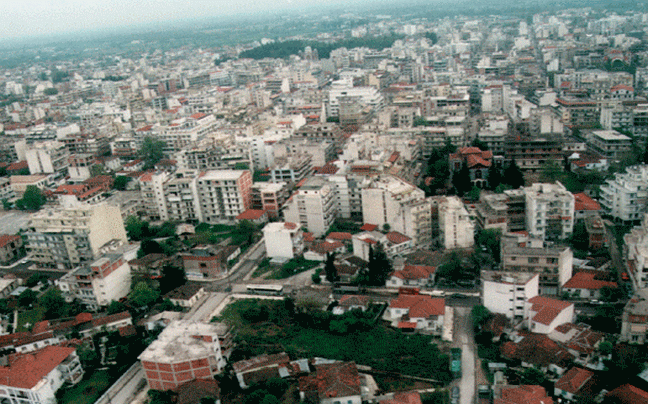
[138,320,232,390]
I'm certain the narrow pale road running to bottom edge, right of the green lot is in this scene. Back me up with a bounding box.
[452,307,475,404]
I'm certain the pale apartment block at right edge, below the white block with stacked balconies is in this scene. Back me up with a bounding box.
[623,213,648,289]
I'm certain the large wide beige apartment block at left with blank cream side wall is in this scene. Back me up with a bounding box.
[25,203,128,269]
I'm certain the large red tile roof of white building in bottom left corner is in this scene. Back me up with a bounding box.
[0,346,75,389]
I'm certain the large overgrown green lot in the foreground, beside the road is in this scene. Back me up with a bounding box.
[214,299,452,387]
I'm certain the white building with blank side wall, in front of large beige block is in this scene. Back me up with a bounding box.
[56,254,131,311]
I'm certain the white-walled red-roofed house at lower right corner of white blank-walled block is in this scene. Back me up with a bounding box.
[526,296,574,334]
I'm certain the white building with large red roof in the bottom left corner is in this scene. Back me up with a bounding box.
[0,346,83,404]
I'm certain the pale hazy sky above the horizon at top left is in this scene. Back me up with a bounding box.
[0,0,330,42]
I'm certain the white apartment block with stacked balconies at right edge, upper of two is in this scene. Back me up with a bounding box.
[599,164,648,222]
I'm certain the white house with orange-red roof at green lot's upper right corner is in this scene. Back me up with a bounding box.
[388,294,445,334]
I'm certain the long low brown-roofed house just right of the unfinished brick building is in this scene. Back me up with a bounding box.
[232,352,290,389]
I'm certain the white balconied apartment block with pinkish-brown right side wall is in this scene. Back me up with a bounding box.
[196,170,252,224]
